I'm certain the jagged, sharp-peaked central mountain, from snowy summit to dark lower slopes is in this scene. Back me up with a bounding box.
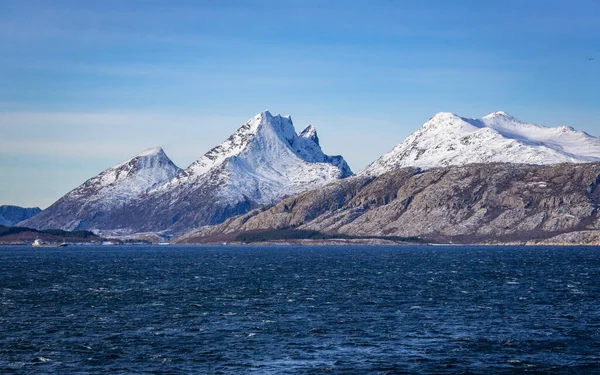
[123,111,352,233]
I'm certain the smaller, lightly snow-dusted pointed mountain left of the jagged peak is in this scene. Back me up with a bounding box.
[19,147,181,230]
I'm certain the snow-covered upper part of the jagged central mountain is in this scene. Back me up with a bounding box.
[157,111,352,204]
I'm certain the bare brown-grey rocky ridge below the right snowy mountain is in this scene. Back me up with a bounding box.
[182,163,600,243]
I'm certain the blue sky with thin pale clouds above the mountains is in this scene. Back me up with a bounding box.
[0,0,600,208]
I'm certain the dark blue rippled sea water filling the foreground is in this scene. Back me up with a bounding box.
[0,246,600,374]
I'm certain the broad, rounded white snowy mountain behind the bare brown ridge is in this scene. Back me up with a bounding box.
[358,112,600,176]
